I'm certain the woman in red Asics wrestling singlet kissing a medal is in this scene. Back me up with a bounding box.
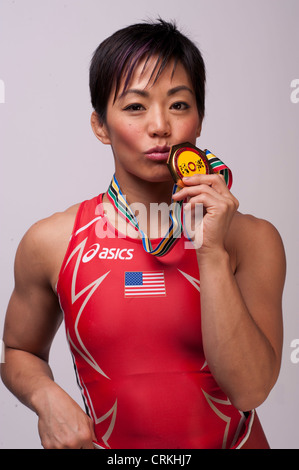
[2,20,285,448]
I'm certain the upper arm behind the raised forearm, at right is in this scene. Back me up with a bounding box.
[235,220,286,367]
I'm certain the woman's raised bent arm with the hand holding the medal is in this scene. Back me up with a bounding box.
[175,175,285,411]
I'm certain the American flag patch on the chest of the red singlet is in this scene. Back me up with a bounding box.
[125,271,166,297]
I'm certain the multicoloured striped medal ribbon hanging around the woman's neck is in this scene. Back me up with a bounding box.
[107,150,232,256]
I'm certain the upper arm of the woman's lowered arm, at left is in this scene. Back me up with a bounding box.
[3,224,62,360]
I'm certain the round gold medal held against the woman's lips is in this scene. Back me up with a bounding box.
[166,142,213,187]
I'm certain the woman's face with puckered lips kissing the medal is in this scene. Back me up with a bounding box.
[93,58,201,182]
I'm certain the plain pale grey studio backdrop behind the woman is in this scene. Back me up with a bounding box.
[0,0,299,448]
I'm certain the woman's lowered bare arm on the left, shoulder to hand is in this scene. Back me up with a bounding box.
[1,216,94,448]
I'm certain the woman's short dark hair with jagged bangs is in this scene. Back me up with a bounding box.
[89,19,206,122]
